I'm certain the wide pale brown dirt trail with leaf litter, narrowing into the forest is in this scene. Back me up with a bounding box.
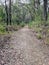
[0,26,49,65]
